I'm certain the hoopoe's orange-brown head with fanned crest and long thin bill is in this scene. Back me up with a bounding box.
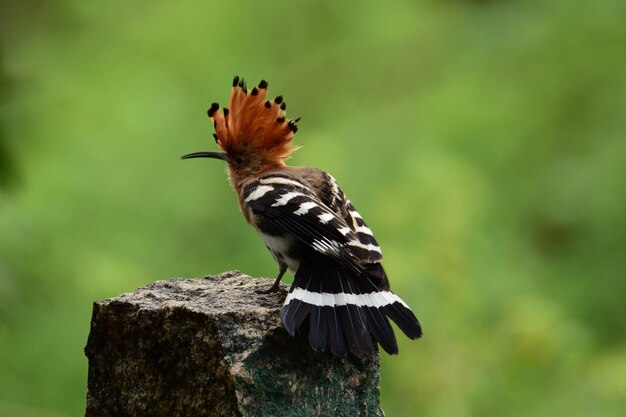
[182,77,299,186]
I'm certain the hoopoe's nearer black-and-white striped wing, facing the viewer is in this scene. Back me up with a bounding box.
[243,177,363,272]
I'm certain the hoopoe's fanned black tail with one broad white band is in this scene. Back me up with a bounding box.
[281,251,422,356]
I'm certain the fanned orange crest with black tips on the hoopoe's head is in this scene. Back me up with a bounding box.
[208,77,299,160]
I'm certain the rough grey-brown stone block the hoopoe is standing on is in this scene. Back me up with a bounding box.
[85,271,384,417]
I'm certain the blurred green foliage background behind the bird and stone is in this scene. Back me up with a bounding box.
[0,0,626,417]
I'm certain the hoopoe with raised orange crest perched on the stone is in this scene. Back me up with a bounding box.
[182,77,422,356]
